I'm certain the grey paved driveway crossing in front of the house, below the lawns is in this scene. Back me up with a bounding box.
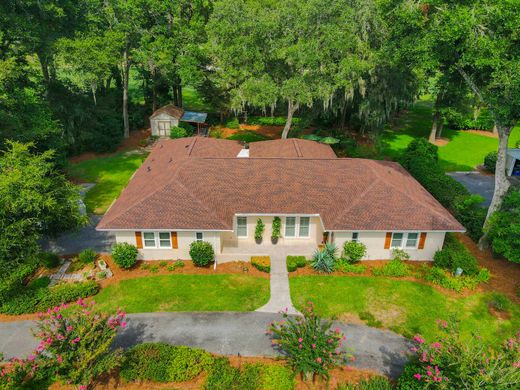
[0,312,410,378]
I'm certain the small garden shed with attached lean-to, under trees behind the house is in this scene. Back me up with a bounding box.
[150,104,208,137]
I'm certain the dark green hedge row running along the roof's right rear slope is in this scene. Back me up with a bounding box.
[401,138,486,241]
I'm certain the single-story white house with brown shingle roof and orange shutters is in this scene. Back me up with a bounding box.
[97,137,465,262]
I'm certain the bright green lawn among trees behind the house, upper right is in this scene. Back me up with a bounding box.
[381,99,520,171]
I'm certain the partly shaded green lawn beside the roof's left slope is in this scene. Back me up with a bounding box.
[67,152,146,214]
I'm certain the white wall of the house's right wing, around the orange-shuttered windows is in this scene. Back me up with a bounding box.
[334,231,446,260]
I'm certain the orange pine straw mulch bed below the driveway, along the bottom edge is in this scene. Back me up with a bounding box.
[49,356,379,390]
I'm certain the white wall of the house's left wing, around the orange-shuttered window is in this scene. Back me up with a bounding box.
[115,230,220,260]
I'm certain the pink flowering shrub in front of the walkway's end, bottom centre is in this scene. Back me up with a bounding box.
[267,302,350,378]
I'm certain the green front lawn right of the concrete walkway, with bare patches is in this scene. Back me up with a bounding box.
[289,276,520,342]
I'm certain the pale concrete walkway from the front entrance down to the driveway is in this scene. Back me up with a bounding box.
[256,251,301,314]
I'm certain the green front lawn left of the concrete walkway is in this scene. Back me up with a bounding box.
[94,274,269,313]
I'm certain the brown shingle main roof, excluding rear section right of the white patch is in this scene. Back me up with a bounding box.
[98,138,464,231]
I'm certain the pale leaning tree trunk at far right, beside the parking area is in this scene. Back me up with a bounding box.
[478,125,511,249]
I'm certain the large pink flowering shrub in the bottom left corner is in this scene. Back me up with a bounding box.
[0,299,126,389]
